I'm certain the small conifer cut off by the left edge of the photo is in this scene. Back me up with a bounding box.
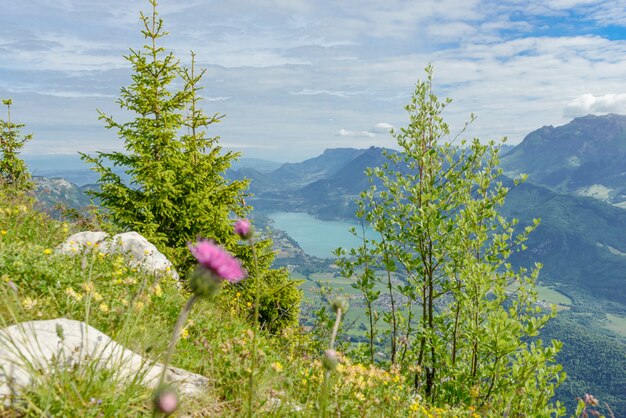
[0,99,33,192]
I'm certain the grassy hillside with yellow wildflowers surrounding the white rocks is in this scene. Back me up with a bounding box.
[0,196,471,417]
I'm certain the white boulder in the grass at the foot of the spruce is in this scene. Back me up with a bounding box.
[56,231,179,279]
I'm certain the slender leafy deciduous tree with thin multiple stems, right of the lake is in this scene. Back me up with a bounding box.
[340,67,564,416]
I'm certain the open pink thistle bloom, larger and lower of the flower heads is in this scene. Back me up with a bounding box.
[189,240,246,283]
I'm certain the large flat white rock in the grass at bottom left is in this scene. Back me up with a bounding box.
[0,318,208,403]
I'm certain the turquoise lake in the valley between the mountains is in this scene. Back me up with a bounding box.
[267,212,371,258]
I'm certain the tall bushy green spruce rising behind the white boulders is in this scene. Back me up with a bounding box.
[83,0,300,334]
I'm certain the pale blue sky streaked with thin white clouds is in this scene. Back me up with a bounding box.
[0,0,626,162]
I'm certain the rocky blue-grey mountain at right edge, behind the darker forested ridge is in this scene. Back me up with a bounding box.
[502,114,626,208]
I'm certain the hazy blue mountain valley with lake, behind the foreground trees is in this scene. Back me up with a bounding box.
[24,115,626,416]
